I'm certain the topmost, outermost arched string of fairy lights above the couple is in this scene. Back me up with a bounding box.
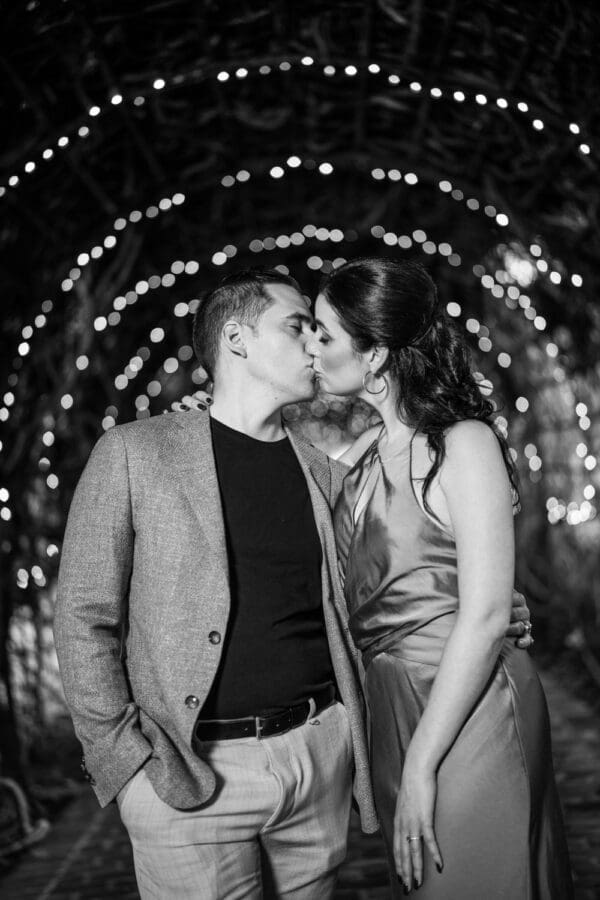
[0,55,592,198]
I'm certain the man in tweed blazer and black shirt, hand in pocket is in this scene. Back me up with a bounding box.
[56,270,536,900]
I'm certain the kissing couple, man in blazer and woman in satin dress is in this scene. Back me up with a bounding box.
[55,258,572,900]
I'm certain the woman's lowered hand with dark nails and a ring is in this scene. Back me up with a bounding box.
[394,758,443,891]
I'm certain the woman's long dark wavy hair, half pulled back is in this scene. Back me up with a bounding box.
[321,257,519,518]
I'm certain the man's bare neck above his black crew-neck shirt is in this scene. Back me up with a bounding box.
[210,385,285,441]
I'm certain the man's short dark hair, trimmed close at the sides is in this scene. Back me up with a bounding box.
[193,267,302,379]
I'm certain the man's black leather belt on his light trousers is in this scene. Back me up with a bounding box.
[194,684,335,741]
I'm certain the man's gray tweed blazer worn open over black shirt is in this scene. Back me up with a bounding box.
[55,412,377,831]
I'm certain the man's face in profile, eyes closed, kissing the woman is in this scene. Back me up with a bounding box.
[245,284,315,406]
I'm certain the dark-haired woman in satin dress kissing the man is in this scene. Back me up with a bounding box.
[311,259,572,900]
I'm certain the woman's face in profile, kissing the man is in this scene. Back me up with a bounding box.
[308,294,369,396]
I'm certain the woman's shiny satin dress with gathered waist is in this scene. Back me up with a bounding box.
[335,434,573,900]
